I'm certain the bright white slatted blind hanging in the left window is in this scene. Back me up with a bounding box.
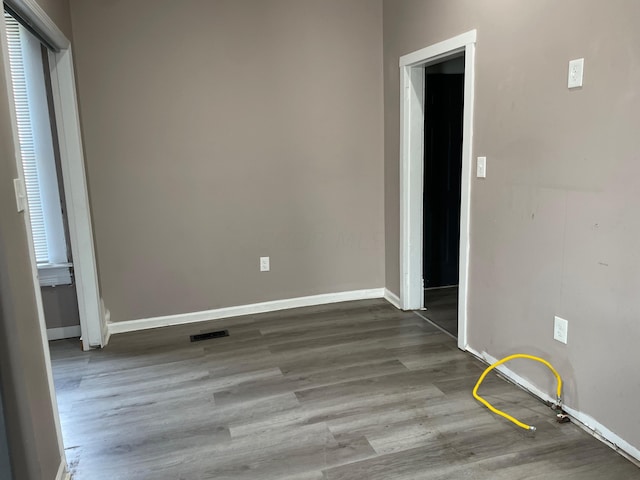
[4,12,50,264]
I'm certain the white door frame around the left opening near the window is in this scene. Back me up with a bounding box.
[2,0,108,350]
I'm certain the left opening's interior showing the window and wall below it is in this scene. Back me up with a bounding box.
[4,11,81,340]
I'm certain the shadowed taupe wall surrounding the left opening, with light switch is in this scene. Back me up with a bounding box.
[0,0,69,480]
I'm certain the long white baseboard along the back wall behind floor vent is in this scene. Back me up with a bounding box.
[108,288,385,335]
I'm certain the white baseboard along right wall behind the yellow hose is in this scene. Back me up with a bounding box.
[467,347,640,465]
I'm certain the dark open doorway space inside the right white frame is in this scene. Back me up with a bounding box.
[422,53,464,337]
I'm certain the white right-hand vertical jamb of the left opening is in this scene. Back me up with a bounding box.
[49,48,104,350]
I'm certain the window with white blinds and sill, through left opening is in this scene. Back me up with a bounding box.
[4,12,71,286]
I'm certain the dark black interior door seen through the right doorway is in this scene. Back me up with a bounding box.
[423,69,464,288]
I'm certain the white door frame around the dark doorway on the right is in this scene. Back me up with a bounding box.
[400,30,477,349]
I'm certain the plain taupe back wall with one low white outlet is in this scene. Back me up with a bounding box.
[71,0,384,322]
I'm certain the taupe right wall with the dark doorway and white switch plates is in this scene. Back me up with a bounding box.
[384,0,640,447]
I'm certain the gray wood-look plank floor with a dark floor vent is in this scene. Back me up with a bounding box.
[51,300,640,480]
